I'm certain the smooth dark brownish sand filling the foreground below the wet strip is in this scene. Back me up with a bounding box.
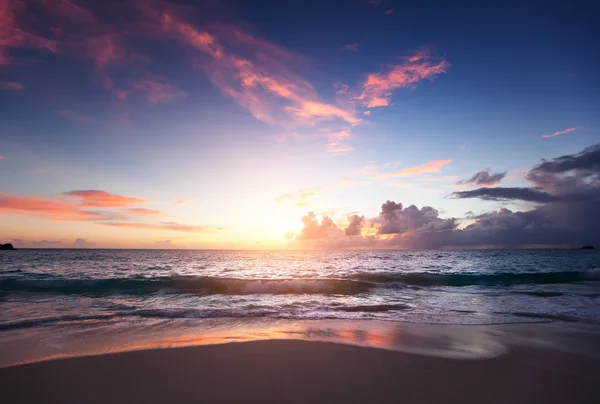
[0,340,600,404]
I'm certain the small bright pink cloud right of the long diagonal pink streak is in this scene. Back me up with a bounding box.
[356,52,450,108]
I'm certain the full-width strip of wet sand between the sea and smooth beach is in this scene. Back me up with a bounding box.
[0,318,600,369]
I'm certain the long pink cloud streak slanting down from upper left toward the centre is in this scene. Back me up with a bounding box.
[138,7,361,131]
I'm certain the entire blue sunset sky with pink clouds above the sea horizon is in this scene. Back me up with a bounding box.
[0,0,600,249]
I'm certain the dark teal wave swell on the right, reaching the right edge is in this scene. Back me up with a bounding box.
[352,269,600,287]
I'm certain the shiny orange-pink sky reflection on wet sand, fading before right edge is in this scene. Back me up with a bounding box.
[0,319,506,366]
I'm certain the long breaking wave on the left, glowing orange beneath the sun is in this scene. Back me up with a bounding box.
[0,277,374,295]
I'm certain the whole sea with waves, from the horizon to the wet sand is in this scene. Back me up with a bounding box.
[0,250,600,332]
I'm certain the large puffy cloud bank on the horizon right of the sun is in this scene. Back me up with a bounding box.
[292,144,600,249]
